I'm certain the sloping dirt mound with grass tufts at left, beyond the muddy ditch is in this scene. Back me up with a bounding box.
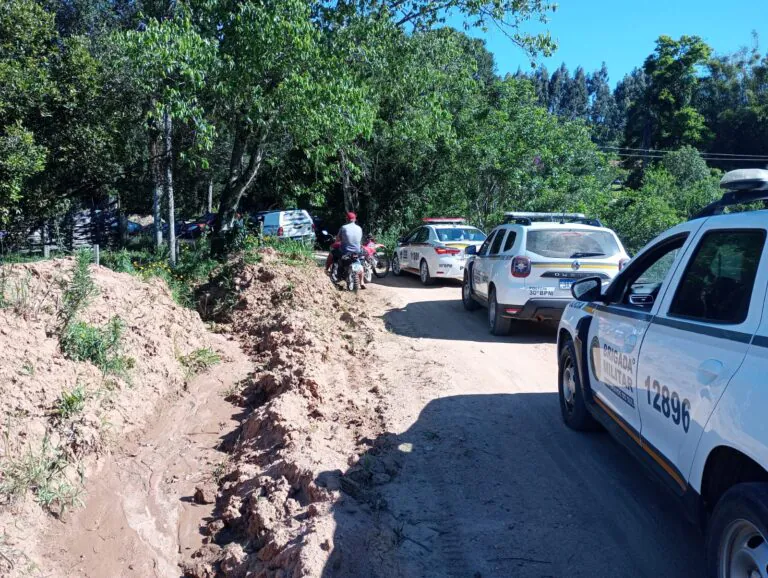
[0,259,219,574]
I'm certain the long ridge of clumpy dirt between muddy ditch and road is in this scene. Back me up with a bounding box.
[185,251,394,578]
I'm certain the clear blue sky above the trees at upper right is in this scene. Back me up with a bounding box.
[449,0,768,85]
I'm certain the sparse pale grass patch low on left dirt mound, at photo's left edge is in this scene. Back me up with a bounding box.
[0,433,83,514]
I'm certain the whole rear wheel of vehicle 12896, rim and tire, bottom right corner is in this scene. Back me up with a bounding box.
[707,483,768,578]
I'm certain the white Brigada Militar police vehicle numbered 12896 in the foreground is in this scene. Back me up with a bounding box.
[558,169,768,578]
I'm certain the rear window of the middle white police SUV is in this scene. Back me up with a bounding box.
[526,229,619,259]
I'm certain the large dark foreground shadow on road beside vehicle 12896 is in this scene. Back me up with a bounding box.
[317,393,704,578]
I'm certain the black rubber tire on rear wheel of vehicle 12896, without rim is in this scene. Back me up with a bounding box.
[706,483,768,578]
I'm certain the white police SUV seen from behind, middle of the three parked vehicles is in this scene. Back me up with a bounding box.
[461,213,629,335]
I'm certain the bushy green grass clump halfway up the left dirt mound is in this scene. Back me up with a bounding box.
[61,316,135,376]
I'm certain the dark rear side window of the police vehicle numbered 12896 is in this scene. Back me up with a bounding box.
[669,230,765,324]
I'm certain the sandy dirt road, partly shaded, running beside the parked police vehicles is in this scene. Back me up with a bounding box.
[325,276,703,578]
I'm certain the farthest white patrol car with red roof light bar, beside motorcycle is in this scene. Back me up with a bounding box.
[392,218,485,285]
